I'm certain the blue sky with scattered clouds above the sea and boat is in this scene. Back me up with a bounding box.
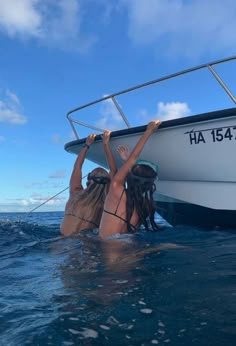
[0,0,236,212]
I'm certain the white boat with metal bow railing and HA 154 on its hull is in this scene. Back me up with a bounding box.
[65,56,236,228]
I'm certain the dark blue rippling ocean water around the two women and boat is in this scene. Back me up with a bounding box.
[0,212,236,346]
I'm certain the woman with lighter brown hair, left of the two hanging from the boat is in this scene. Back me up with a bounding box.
[61,131,117,236]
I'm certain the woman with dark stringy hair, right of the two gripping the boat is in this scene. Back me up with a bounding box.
[99,120,161,238]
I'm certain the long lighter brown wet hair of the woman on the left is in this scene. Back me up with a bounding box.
[69,167,110,227]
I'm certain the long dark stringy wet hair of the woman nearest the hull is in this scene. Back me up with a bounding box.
[126,164,159,232]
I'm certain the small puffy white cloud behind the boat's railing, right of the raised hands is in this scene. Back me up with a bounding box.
[154,102,191,121]
